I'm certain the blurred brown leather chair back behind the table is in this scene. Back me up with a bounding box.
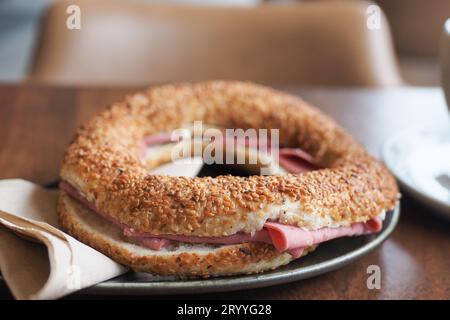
[29,0,401,86]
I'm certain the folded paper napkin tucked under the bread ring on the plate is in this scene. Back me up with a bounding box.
[0,159,202,299]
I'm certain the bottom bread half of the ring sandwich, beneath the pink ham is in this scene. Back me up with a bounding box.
[58,191,315,277]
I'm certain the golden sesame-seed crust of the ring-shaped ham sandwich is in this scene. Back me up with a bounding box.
[59,81,398,275]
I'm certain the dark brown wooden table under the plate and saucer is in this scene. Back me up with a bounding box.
[0,85,450,299]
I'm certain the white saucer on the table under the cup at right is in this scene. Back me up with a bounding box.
[382,128,450,218]
